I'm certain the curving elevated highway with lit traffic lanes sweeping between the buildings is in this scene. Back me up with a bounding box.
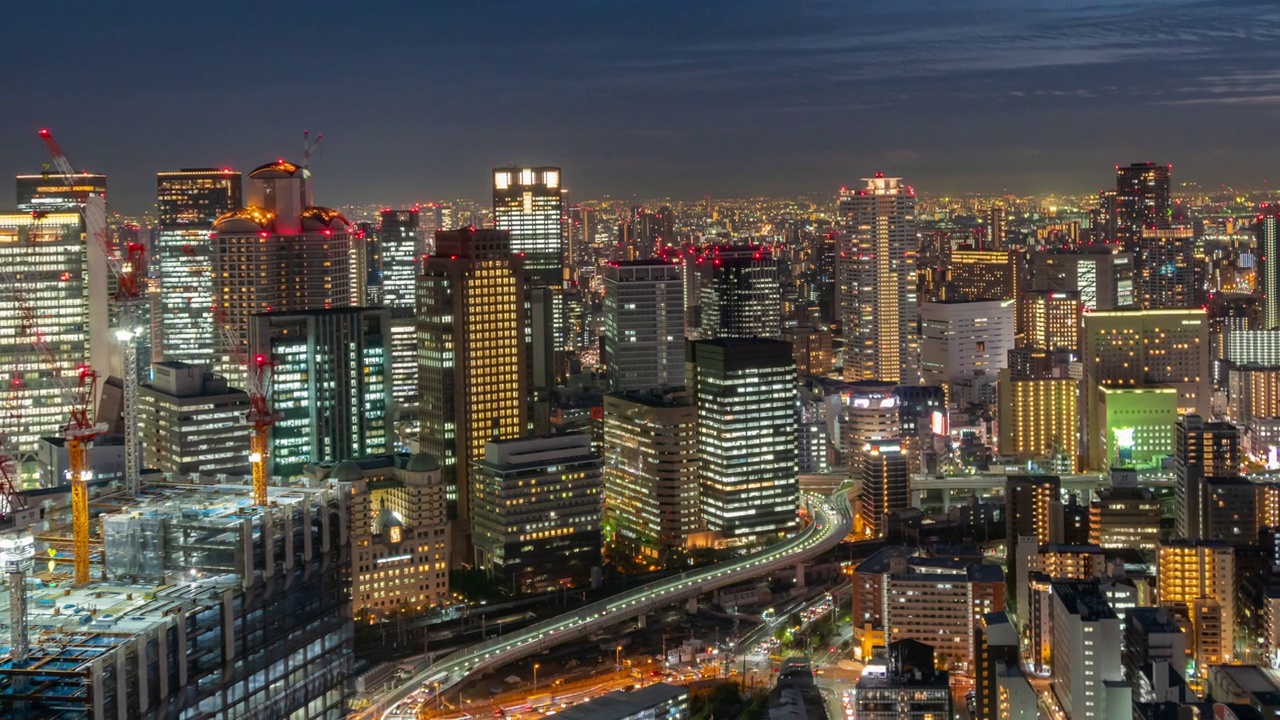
[355,492,852,720]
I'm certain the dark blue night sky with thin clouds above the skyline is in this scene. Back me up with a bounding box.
[0,0,1280,213]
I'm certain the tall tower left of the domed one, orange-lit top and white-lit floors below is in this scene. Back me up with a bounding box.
[152,168,243,368]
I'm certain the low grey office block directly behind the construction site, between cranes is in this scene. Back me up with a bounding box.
[138,361,250,478]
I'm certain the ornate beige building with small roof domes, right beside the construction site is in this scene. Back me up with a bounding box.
[307,452,452,618]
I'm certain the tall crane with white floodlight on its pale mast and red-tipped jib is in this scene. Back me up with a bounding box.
[40,129,147,499]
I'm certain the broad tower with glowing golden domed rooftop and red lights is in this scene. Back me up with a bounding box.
[209,160,356,387]
